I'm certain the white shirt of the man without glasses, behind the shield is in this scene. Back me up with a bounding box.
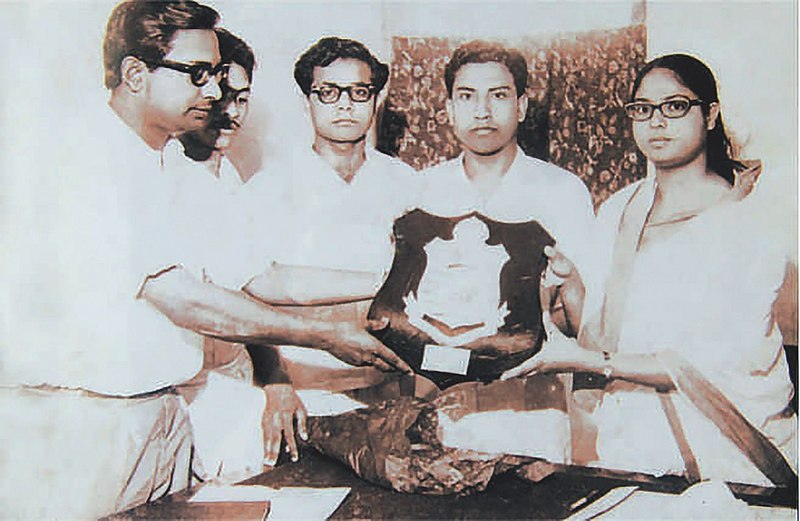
[420,147,594,282]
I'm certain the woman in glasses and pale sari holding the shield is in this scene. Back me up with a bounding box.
[504,54,797,486]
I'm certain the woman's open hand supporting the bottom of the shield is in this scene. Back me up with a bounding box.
[500,338,605,380]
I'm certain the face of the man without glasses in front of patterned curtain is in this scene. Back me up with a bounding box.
[447,62,528,156]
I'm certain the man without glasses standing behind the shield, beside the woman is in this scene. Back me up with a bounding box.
[421,40,594,350]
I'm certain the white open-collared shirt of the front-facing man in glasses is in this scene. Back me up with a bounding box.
[240,142,417,280]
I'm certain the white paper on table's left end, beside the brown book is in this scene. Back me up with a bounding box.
[189,485,350,520]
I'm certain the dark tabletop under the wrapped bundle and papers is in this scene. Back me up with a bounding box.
[113,372,797,520]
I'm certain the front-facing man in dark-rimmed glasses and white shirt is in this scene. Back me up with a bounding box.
[238,37,416,388]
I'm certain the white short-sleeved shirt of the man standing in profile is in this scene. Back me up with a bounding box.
[0,107,238,395]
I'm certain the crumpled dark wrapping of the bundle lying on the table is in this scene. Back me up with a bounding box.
[309,375,568,495]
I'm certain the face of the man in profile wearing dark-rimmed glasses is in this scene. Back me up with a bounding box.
[144,29,221,135]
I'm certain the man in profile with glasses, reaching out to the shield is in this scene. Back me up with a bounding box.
[0,0,412,519]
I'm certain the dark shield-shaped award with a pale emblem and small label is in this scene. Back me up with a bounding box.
[368,209,555,388]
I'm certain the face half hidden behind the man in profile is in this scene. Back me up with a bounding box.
[190,63,250,151]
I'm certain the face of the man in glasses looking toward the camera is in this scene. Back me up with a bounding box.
[307,58,375,143]
